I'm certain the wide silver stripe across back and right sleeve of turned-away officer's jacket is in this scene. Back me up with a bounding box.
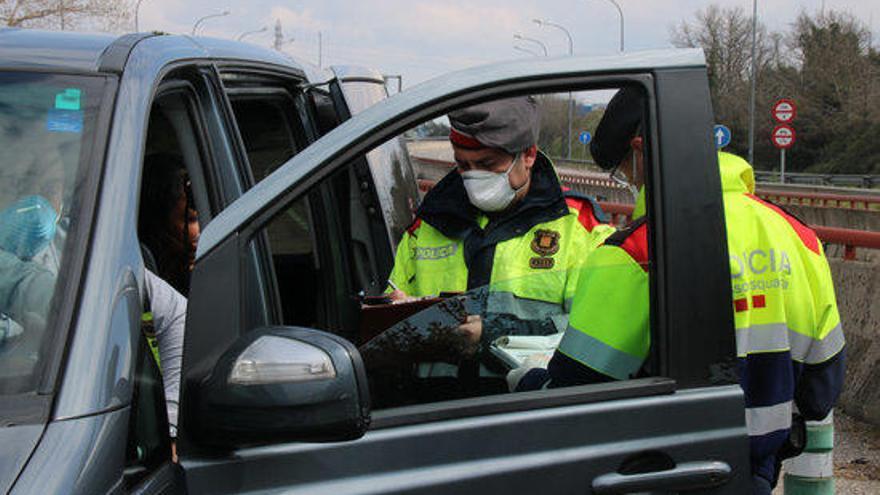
[736,323,846,364]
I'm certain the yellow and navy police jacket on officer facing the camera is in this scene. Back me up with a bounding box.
[390,153,614,339]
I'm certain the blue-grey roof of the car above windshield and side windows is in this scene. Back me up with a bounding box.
[0,28,321,79]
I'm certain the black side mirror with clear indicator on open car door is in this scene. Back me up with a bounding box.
[185,327,370,448]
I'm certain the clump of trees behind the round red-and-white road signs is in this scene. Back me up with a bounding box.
[671,5,880,173]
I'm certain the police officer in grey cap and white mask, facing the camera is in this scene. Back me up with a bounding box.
[390,97,614,356]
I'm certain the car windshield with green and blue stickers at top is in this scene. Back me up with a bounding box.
[0,72,105,395]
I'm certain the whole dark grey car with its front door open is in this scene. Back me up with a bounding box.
[0,31,750,495]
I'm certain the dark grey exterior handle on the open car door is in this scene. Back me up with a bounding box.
[593,461,732,495]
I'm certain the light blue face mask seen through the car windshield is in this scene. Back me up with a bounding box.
[0,195,58,260]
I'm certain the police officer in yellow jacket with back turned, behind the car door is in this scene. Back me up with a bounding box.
[517,89,844,494]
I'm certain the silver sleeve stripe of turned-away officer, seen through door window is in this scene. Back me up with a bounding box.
[558,326,644,380]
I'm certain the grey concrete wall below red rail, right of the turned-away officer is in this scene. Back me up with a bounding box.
[830,259,880,426]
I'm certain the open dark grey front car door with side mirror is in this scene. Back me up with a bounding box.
[179,50,751,495]
